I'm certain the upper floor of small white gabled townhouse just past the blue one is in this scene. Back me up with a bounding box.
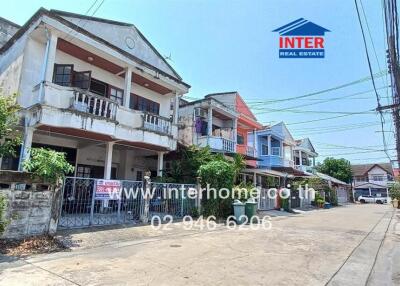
[293,138,318,173]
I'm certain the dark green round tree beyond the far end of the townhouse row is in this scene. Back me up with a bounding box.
[317,157,353,183]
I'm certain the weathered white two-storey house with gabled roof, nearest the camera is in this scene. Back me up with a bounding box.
[0,9,190,180]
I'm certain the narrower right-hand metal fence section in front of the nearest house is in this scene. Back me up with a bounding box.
[149,183,196,218]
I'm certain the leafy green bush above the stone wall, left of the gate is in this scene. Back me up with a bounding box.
[24,148,74,184]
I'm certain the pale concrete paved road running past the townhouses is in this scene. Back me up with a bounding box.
[0,205,400,286]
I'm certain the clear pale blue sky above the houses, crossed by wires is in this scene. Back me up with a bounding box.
[0,0,395,164]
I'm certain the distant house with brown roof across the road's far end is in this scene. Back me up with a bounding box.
[351,163,394,200]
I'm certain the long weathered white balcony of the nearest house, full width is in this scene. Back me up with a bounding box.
[38,83,177,140]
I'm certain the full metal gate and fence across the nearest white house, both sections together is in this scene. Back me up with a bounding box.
[58,177,196,229]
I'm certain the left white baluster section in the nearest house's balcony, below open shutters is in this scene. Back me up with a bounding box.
[73,90,118,120]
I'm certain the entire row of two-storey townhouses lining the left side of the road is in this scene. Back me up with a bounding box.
[0,9,354,232]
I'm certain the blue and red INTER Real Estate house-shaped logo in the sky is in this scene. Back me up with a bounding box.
[272,18,330,58]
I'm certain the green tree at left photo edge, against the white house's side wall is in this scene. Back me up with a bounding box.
[0,95,21,157]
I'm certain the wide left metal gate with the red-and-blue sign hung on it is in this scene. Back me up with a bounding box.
[58,177,144,229]
